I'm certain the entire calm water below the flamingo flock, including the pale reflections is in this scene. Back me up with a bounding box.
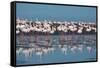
[16,34,96,65]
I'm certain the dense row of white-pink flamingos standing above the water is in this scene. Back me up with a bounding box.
[16,19,97,34]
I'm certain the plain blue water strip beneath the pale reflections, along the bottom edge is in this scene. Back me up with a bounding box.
[17,49,96,65]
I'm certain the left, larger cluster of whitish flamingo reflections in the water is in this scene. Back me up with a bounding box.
[16,47,54,58]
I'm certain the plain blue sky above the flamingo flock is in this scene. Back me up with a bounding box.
[16,3,96,22]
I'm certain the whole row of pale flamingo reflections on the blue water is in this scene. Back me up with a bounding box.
[16,45,93,58]
